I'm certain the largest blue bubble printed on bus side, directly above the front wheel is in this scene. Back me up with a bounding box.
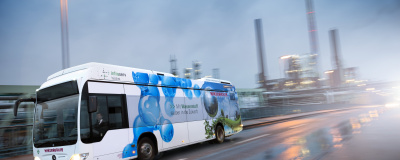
[138,96,161,126]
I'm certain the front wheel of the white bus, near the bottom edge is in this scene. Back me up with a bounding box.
[138,137,156,160]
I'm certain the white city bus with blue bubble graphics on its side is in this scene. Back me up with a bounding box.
[14,63,243,160]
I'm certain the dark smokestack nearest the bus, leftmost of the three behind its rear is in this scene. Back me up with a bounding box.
[254,19,267,89]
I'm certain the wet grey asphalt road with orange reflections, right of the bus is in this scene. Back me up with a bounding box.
[160,107,400,160]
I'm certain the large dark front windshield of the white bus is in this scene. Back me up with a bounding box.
[33,81,79,148]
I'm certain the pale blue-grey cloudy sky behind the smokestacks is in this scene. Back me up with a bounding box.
[0,0,400,88]
